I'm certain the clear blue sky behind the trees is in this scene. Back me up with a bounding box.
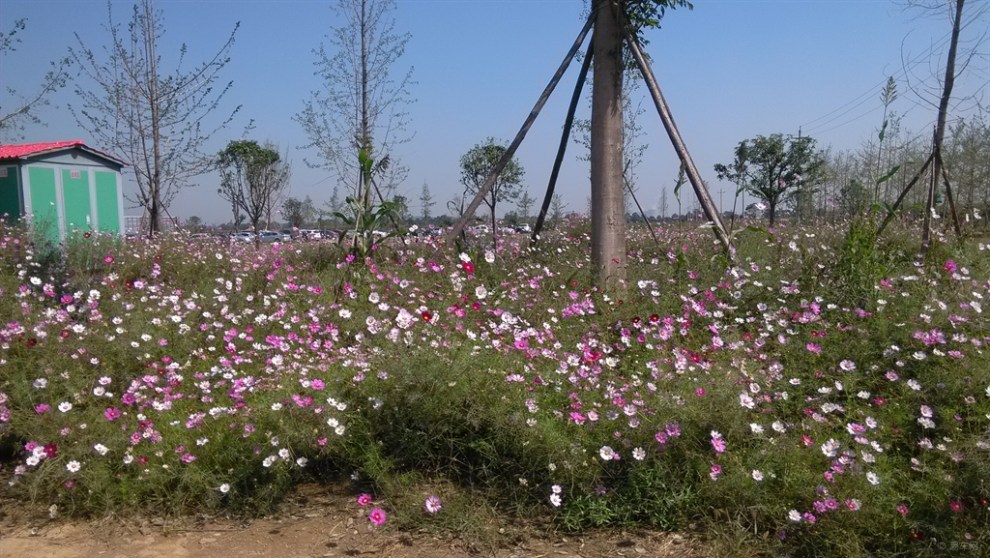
[0,0,990,222]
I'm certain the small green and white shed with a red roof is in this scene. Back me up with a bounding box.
[0,140,124,242]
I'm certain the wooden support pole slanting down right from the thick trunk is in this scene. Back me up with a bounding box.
[622,19,735,262]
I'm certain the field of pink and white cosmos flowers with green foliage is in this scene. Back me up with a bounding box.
[0,222,990,556]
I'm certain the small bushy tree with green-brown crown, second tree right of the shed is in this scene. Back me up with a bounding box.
[216,140,289,236]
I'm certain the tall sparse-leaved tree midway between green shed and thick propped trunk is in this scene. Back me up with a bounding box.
[294,0,413,218]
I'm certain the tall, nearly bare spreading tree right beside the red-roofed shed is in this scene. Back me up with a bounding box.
[69,0,240,235]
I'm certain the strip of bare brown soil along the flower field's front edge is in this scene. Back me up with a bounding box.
[0,485,706,558]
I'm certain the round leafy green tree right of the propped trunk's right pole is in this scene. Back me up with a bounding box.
[715,134,824,227]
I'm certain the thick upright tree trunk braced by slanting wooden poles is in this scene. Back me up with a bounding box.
[591,0,626,292]
